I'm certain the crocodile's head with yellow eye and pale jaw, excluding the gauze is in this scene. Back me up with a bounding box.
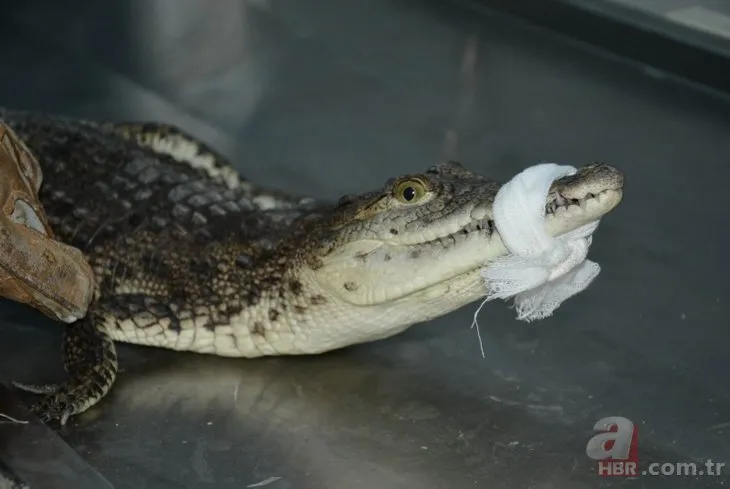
[292,162,623,344]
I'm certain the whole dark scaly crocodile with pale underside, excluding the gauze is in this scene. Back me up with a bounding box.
[0,109,624,425]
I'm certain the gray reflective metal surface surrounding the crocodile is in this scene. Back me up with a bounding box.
[0,0,730,489]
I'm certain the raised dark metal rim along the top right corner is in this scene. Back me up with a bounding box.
[472,0,730,94]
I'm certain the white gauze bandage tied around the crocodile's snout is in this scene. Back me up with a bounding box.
[477,163,601,321]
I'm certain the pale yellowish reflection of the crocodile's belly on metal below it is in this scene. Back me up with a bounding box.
[91,354,458,489]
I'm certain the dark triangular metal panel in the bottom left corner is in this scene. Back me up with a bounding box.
[0,385,113,489]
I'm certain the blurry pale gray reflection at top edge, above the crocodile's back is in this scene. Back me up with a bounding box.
[130,0,266,126]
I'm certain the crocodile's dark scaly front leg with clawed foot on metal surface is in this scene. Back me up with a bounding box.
[14,313,117,425]
